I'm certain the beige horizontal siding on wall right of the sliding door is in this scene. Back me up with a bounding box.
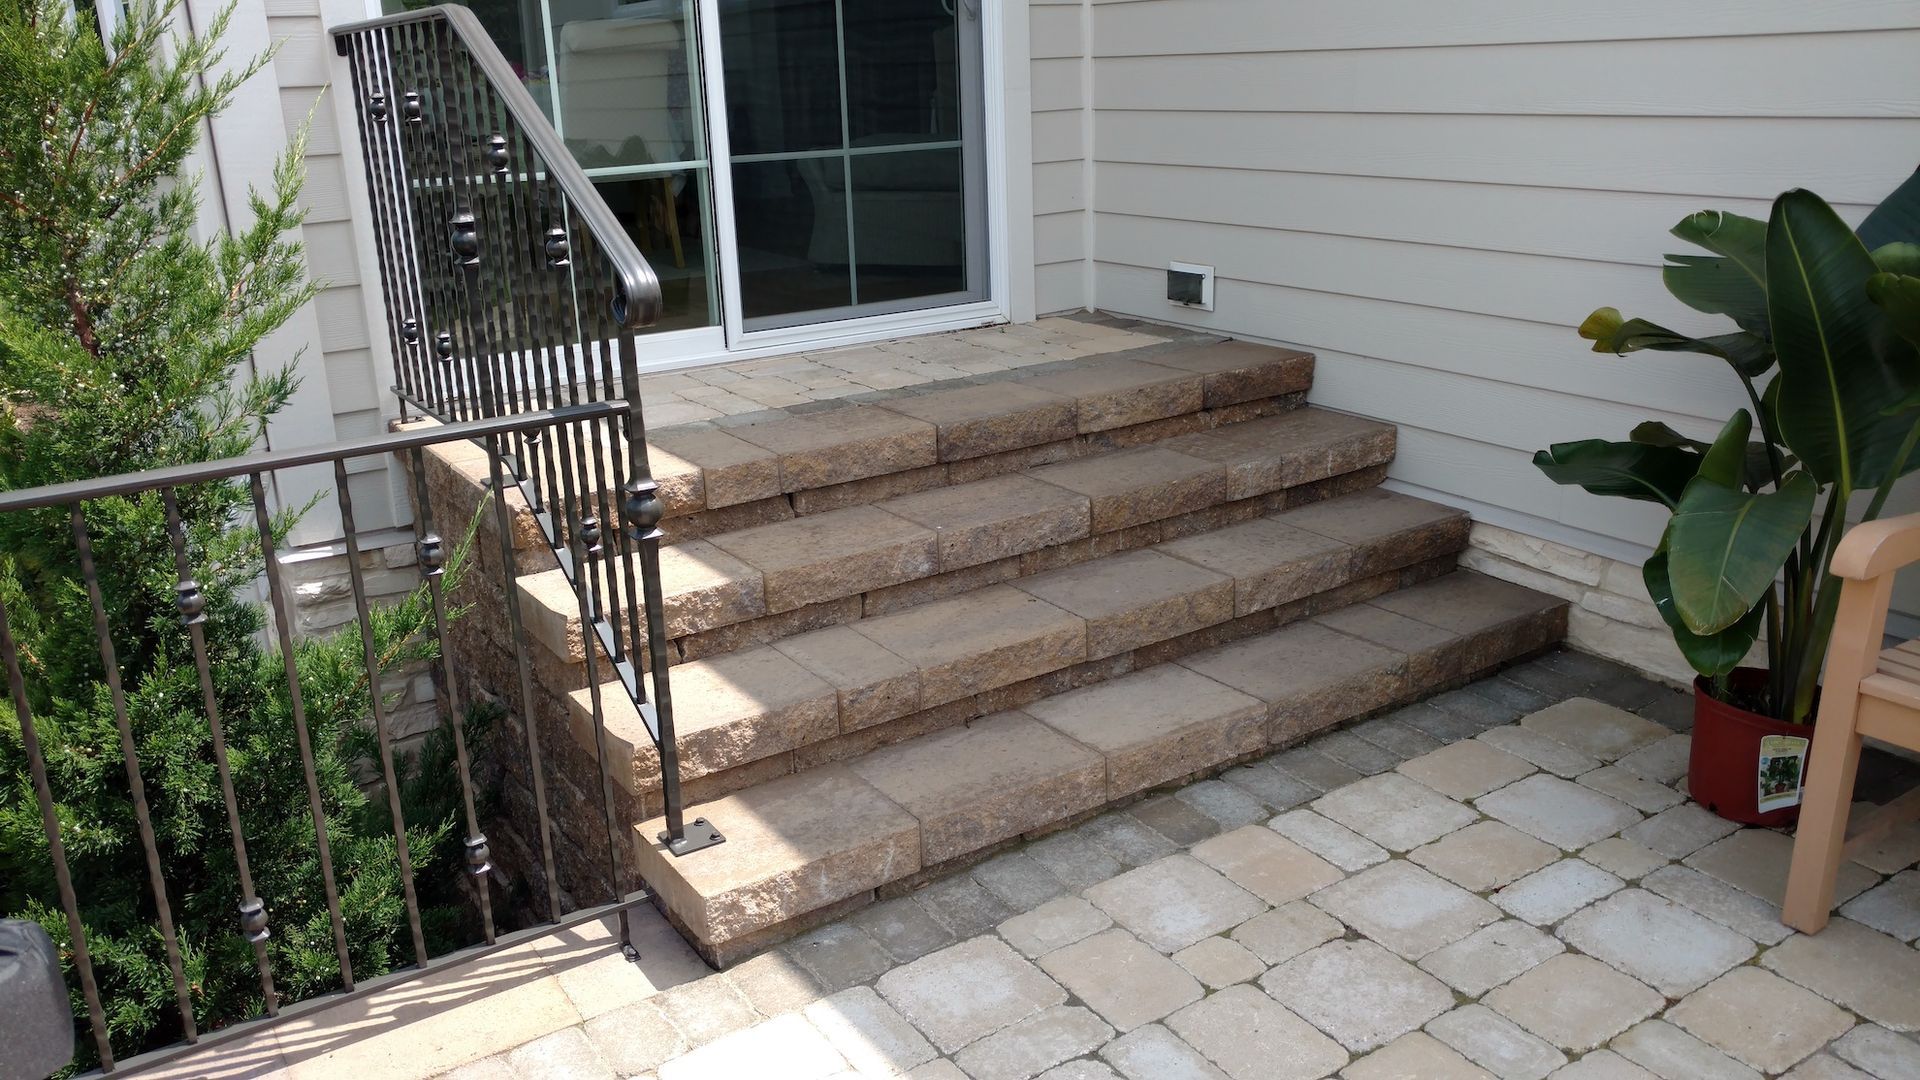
[1082,0,1920,572]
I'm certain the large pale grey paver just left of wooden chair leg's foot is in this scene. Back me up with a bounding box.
[1559,888,1753,997]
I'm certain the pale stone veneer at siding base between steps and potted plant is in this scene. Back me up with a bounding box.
[1459,521,1693,686]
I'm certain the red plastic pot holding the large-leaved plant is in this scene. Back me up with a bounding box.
[1686,667,1812,828]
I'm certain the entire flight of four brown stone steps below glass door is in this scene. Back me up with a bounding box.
[416,322,1567,965]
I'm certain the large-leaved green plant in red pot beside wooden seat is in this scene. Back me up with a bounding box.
[1534,173,1920,824]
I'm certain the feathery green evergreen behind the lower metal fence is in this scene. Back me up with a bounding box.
[0,0,490,1067]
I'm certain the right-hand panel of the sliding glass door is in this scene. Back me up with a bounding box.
[718,0,987,331]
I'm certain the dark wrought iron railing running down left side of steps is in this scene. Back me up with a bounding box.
[332,6,722,855]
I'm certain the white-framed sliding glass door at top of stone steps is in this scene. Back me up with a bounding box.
[388,0,987,343]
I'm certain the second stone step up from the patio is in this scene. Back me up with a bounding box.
[568,488,1469,794]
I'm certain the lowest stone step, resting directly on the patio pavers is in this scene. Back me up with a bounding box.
[636,571,1567,953]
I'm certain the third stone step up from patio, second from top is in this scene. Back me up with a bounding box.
[518,411,1394,661]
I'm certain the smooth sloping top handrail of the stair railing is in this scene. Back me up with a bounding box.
[330,4,660,331]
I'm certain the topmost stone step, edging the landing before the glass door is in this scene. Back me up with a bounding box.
[647,342,1313,515]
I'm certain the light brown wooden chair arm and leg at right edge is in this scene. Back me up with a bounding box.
[1782,513,1920,934]
